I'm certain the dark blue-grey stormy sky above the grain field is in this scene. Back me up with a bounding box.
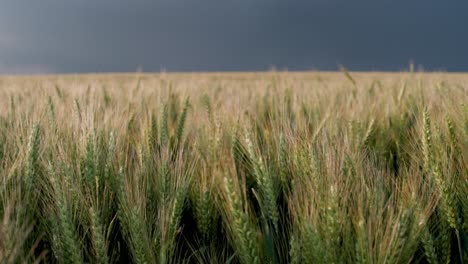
[0,0,468,73]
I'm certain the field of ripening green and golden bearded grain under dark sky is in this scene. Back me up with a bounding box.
[0,71,468,264]
